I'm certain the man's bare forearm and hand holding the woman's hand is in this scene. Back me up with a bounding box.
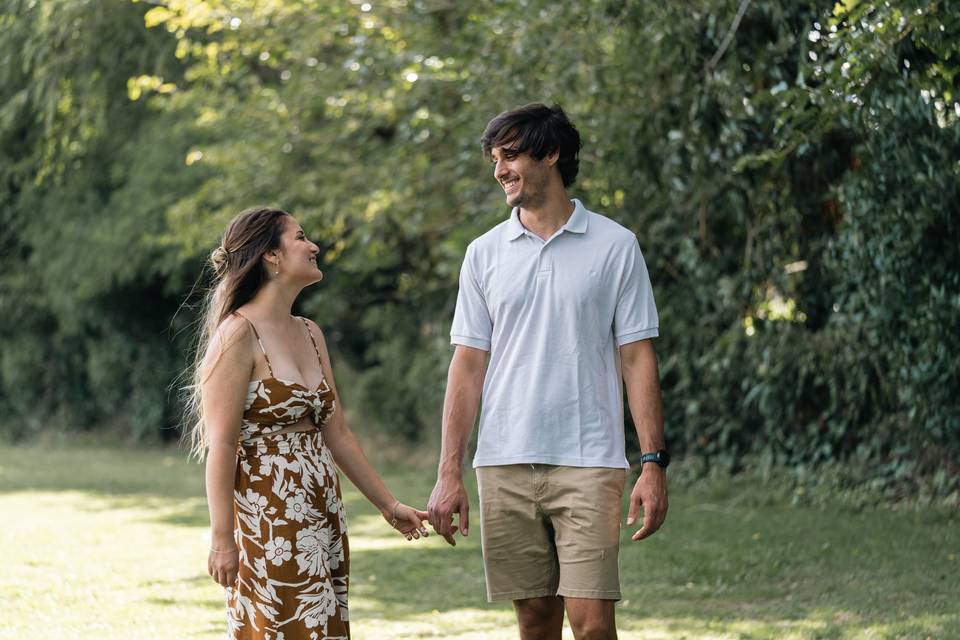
[427,345,487,546]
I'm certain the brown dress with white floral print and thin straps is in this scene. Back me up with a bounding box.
[226,318,350,640]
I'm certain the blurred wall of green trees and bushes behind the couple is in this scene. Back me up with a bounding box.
[0,0,960,501]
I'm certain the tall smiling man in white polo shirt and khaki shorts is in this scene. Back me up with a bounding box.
[429,104,668,640]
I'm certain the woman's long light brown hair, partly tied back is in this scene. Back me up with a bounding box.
[183,207,290,460]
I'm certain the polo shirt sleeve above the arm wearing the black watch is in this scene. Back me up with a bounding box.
[613,237,660,347]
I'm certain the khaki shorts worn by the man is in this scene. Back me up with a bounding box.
[477,464,626,602]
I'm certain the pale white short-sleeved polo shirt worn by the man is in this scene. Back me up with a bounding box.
[450,200,659,468]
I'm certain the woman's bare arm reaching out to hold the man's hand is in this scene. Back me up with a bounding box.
[308,320,427,540]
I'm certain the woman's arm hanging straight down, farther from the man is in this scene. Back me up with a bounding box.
[200,317,253,587]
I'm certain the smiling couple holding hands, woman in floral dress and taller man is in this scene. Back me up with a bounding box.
[191,104,669,640]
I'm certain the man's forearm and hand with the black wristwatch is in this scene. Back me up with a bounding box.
[620,339,667,540]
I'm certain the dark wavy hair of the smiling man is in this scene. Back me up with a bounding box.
[480,102,583,187]
